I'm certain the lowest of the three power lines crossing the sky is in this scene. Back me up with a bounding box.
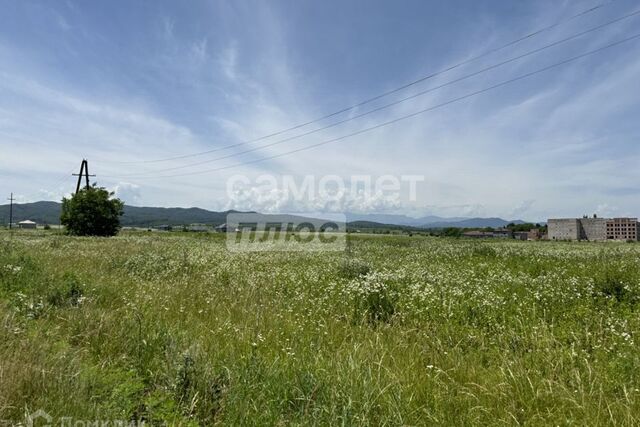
[102,33,640,178]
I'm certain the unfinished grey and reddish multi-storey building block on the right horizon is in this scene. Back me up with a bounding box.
[547,215,640,241]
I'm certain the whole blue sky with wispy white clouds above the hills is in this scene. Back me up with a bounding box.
[0,0,640,220]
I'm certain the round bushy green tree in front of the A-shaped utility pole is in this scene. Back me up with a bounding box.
[60,185,124,236]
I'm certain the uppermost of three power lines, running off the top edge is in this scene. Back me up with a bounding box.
[102,0,615,164]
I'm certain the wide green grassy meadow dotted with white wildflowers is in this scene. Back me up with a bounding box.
[0,231,640,425]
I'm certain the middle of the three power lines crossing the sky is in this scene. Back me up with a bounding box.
[109,10,640,178]
